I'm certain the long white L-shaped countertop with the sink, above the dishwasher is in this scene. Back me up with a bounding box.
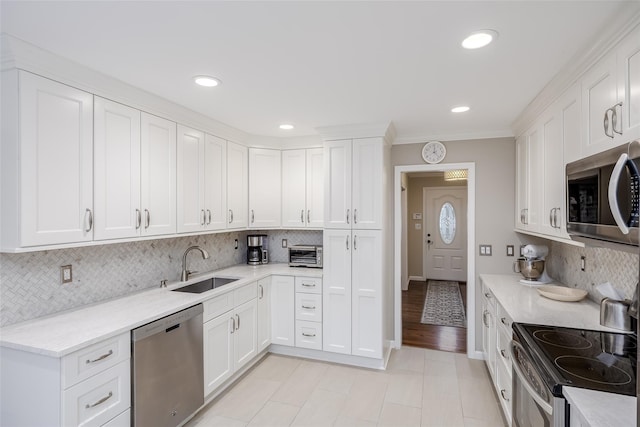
[0,264,322,357]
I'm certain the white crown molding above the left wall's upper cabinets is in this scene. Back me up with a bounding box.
[0,33,249,145]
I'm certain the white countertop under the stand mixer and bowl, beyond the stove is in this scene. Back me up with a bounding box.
[480,274,623,333]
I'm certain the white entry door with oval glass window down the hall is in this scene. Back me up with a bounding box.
[423,187,467,282]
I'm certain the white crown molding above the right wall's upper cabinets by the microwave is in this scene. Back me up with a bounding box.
[511,2,640,135]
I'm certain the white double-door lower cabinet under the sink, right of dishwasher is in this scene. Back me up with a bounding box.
[203,282,258,397]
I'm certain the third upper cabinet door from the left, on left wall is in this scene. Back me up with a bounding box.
[140,112,176,236]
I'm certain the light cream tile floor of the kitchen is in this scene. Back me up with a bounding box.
[186,347,505,427]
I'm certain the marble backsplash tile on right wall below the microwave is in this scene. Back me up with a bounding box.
[546,242,638,303]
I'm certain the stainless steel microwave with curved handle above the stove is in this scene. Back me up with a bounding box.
[566,140,640,246]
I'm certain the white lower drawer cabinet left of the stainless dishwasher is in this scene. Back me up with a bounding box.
[0,332,131,427]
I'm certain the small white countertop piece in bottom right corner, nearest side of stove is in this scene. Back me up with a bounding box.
[562,387,637,427]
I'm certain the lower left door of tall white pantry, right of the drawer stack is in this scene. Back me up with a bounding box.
[322,230,351,354]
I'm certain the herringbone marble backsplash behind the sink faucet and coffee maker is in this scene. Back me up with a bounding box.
[0,230,322,326]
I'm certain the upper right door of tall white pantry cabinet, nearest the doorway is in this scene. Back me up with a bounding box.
[351,138,384,230]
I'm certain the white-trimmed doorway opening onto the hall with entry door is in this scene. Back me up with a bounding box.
[394,163,478,358]
